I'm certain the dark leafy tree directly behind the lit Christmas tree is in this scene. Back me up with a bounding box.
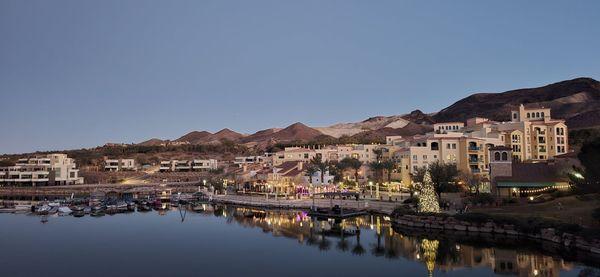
[413,161,459,198]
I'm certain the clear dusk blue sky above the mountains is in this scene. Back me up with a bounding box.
[0,0,600,153]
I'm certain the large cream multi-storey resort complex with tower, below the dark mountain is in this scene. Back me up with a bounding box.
[386,105,569,180]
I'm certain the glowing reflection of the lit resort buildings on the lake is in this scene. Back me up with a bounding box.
[185,205,573,276]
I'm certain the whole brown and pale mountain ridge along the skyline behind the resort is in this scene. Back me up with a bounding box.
[139,78,600,148]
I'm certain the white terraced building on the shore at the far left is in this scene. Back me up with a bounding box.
[0,154,83,186]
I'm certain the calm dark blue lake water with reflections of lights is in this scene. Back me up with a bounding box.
[0,205,600,276]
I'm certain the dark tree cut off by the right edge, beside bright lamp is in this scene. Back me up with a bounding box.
[569,138,600,193]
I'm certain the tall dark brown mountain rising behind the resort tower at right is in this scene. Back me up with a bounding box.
[433,78,600,128]
